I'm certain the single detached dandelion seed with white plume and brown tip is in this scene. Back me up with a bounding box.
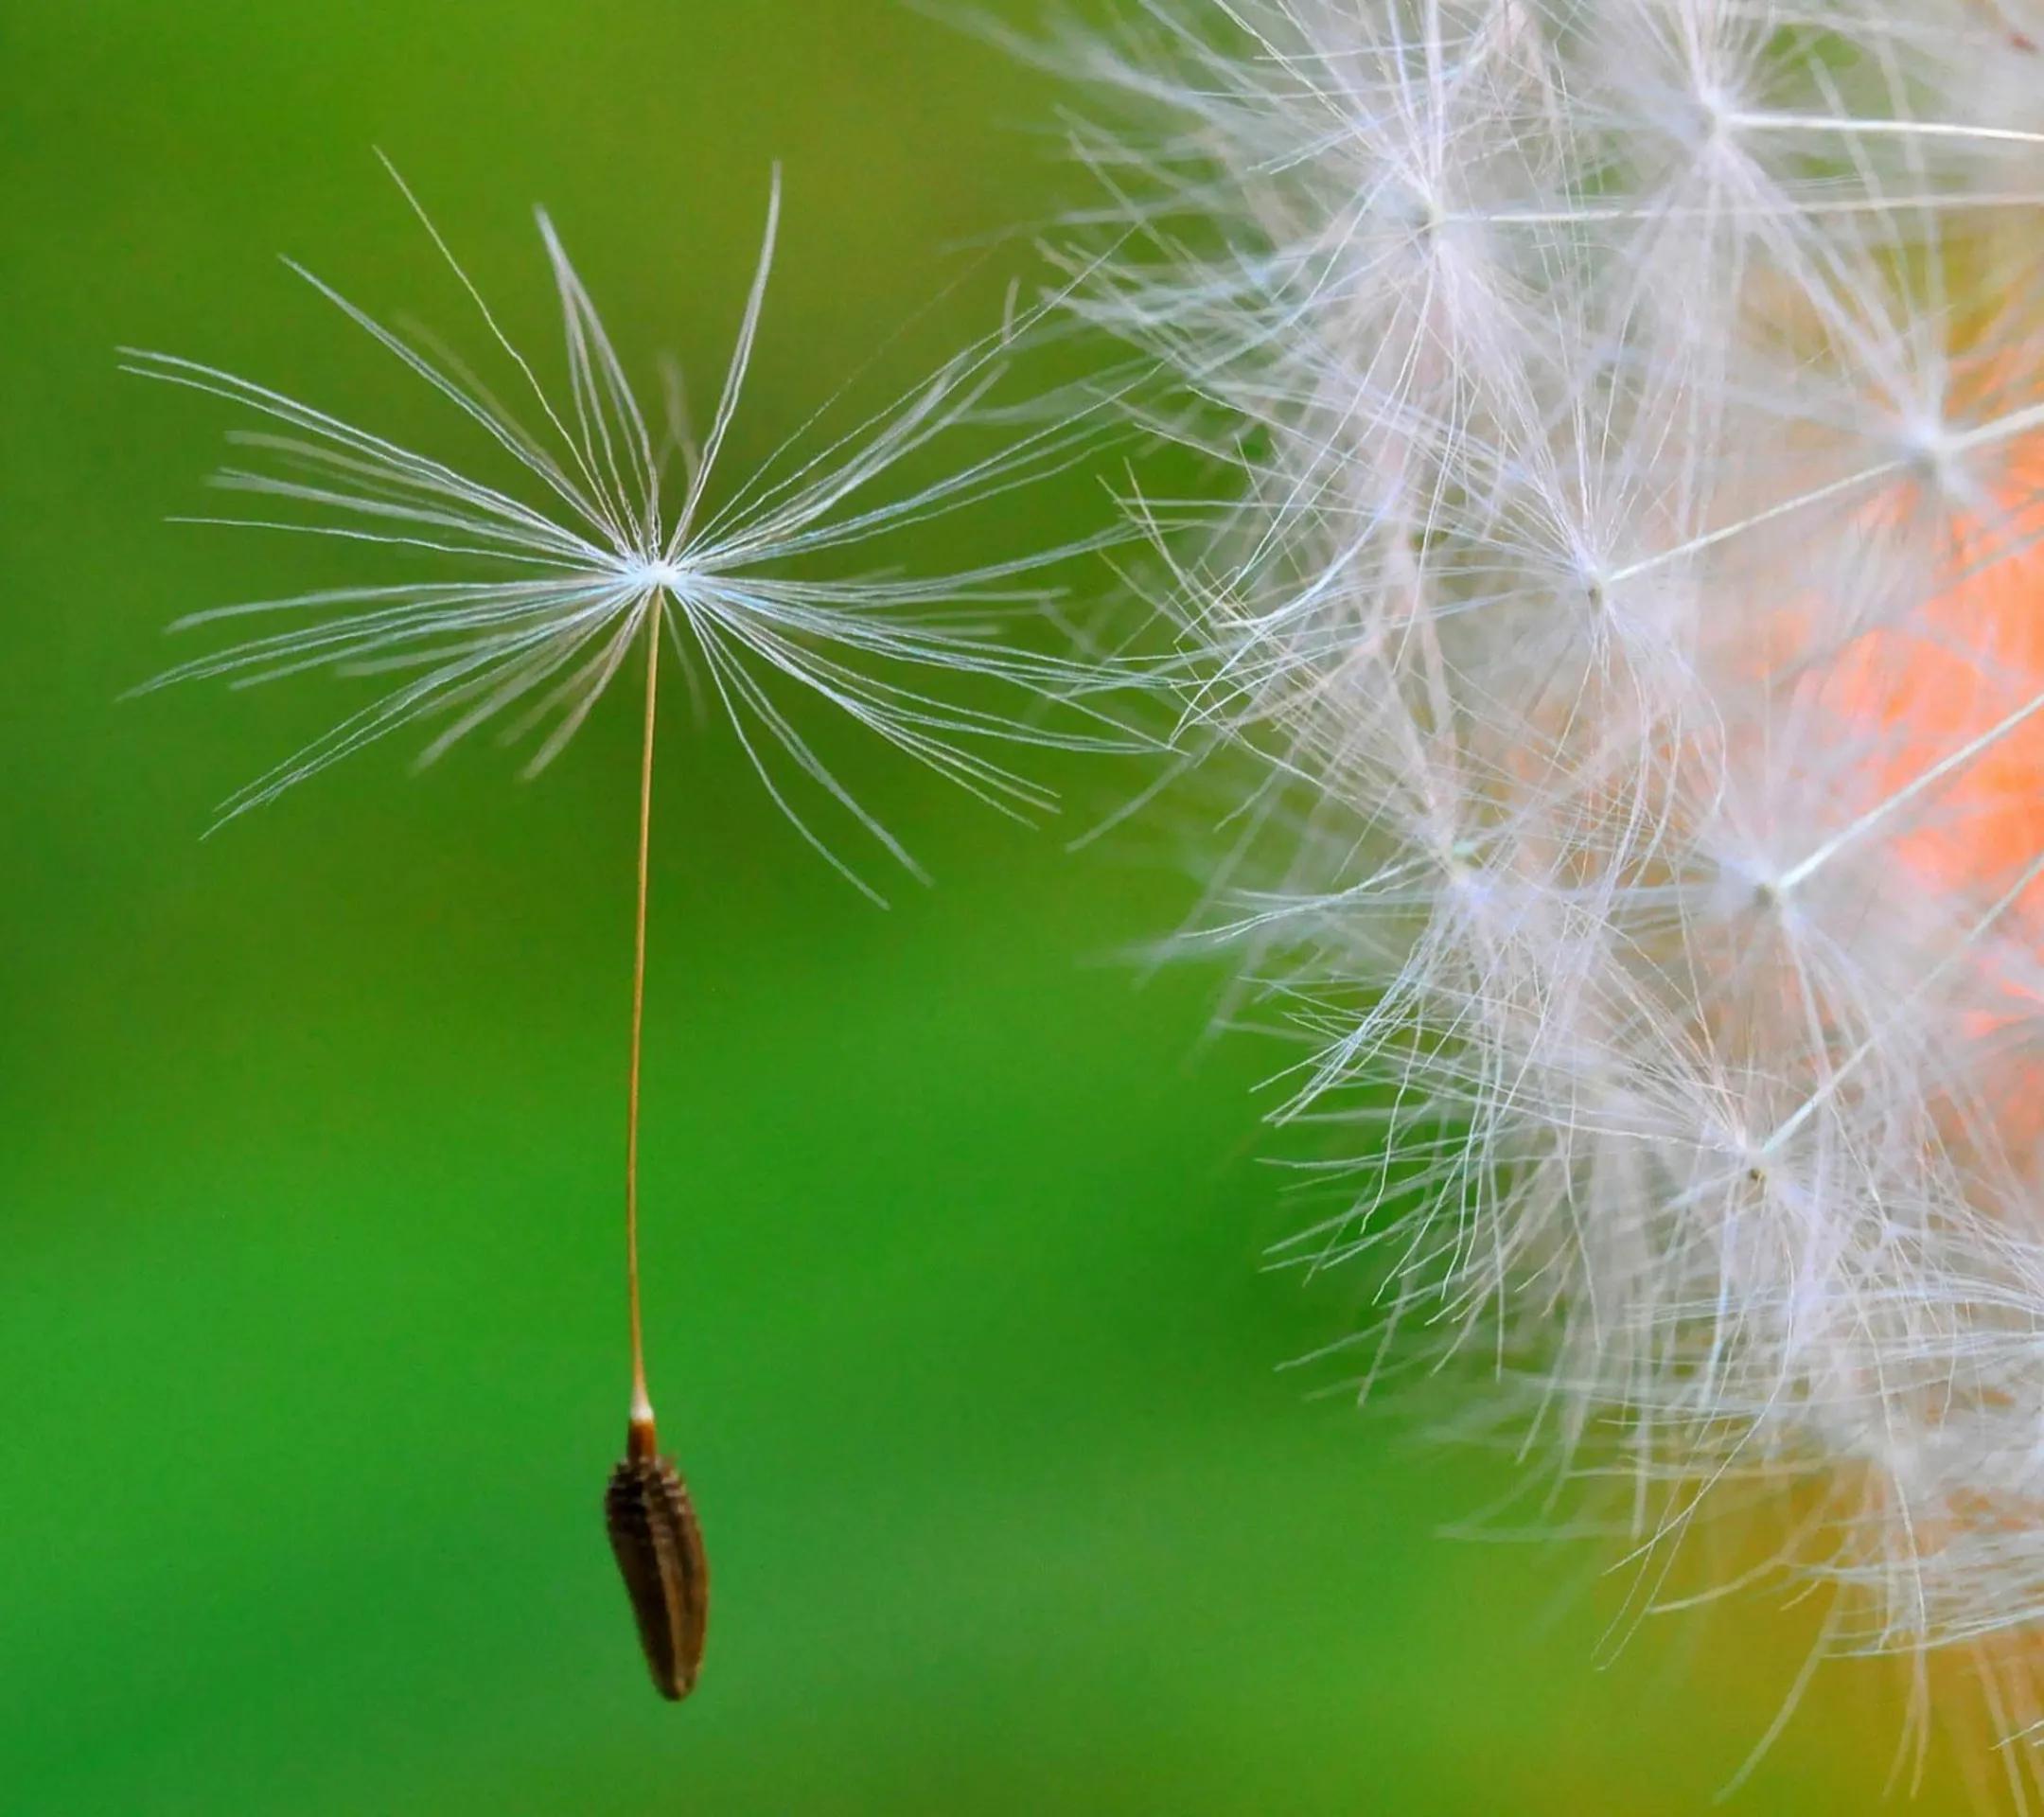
[125,164,1124,1699]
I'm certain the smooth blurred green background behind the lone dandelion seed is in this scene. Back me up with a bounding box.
[0,0,1958,1817]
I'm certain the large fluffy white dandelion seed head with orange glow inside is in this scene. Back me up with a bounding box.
[1069,0,2044,1801]
